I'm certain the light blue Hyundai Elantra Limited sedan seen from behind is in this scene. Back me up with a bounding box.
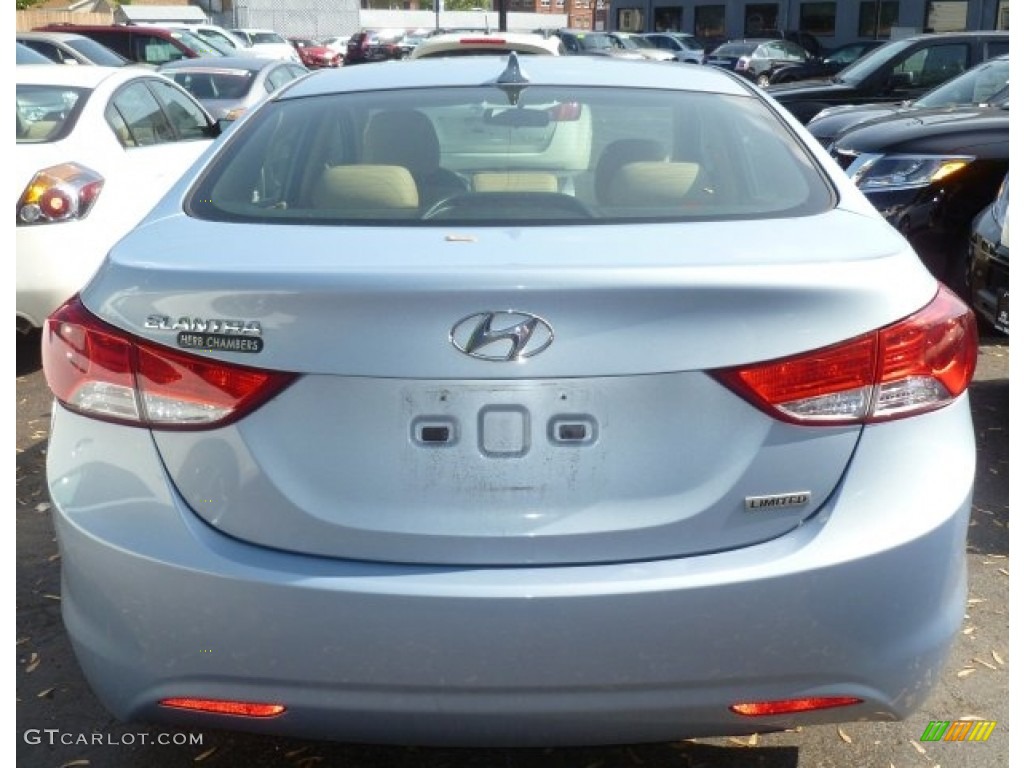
[43,54,977,745]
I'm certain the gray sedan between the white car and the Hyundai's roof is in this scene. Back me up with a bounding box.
[160,56,309,120]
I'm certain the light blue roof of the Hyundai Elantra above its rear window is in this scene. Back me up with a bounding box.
[281,56,753,98]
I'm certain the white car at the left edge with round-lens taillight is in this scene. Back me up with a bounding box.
[12,67,218,332]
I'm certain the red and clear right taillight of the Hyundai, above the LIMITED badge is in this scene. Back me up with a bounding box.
[715,287,978,424]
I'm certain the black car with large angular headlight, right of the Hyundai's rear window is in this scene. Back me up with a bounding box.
[831,101,1010,295]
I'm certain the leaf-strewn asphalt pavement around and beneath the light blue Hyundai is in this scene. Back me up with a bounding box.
[15,336,1010,768]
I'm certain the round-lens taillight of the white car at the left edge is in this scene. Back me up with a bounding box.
[17,163,103,225]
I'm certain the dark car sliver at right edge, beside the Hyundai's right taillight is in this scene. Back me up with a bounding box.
[968,174,1010,335]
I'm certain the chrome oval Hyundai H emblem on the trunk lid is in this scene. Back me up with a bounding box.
[449,310,555,362]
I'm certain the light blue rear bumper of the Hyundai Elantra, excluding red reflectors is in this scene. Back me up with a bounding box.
[48,397,975,745]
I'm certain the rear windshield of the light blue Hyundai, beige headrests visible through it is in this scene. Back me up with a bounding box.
[187,85,833,227]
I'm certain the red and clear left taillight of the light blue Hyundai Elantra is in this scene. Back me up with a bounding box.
[43,297,295,429]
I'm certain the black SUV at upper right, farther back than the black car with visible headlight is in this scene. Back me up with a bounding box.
[768,32,1010,123]
